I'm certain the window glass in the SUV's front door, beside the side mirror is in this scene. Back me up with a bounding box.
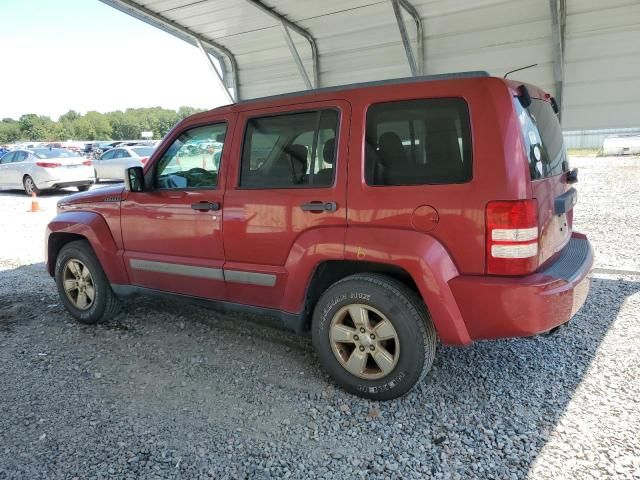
[156,123,227,189]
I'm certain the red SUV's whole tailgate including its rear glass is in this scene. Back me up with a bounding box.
[514,98,578,265]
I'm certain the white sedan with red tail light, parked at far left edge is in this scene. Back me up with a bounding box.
[0,148,95,195]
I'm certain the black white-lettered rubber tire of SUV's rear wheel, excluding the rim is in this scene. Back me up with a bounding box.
[312,274,437,400]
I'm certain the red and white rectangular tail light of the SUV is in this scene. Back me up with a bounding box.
[486,200,539,275]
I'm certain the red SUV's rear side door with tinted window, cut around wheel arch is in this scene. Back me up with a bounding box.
[224,101,350,309]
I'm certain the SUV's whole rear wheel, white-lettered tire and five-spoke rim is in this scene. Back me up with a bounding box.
[312,274,437,400]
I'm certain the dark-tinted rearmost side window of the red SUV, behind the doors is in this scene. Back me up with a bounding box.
[365,98,472,186]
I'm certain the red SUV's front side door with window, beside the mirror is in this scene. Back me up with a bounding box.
[122,116,233,300]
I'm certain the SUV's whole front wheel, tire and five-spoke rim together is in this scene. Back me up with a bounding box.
[55,240,119,324]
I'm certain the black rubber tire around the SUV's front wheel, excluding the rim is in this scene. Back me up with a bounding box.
[55,240,120,324]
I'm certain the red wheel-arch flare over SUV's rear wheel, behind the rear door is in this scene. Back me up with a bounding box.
[345,227,471,345]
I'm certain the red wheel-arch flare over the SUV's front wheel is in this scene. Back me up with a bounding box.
[45,211,129,285]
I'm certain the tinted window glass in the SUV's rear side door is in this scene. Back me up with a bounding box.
[240,110,338,188]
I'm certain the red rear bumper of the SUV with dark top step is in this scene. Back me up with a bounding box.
[449,233,593,340]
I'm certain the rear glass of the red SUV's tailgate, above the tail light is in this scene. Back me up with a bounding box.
[513,97,569,180]
